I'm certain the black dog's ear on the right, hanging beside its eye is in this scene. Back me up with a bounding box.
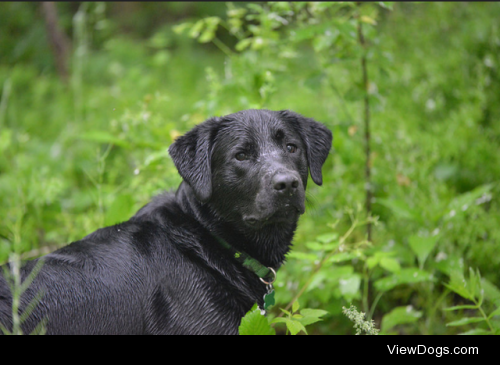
[279,110,333,185]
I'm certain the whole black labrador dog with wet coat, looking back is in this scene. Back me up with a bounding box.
[0,110,332,334]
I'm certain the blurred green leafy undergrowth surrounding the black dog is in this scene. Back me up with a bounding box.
[0,2,500,334]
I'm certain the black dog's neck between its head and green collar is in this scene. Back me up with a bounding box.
[176,182,297,269]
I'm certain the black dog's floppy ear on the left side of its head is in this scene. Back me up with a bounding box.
[168,118,219,203]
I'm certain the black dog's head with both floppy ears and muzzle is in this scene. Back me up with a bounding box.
[169,110,332,228]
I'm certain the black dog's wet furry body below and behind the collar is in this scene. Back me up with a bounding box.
[0,194,256,335]
